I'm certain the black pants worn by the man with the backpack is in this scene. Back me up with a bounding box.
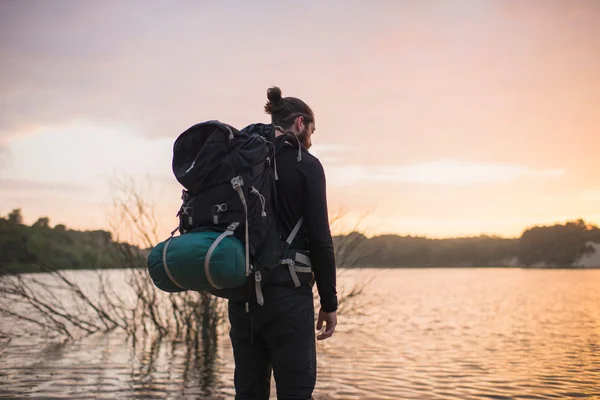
[229,285,317,400]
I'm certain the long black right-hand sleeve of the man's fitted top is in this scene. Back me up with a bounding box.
[303,159,338,312]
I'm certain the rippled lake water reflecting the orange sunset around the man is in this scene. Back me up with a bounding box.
[0,269,600,399]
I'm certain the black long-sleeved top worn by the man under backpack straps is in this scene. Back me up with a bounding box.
[245,124,338,312]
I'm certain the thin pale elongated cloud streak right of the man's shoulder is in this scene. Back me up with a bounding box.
[326,160,565,186]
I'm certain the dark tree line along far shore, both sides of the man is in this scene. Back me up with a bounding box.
[0,209,600,274]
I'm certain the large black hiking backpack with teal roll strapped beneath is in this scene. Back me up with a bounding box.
[147,120,310,305]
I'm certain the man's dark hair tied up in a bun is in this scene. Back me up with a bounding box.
[265,86,315,129]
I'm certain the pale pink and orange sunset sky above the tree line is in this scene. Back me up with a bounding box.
[0,0,600,237]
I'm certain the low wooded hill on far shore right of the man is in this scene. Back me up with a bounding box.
[334,220,600,268]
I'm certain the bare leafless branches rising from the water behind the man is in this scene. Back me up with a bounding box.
[0,175,368,344]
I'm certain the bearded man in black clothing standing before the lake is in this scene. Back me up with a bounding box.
[229,87,338,400]
